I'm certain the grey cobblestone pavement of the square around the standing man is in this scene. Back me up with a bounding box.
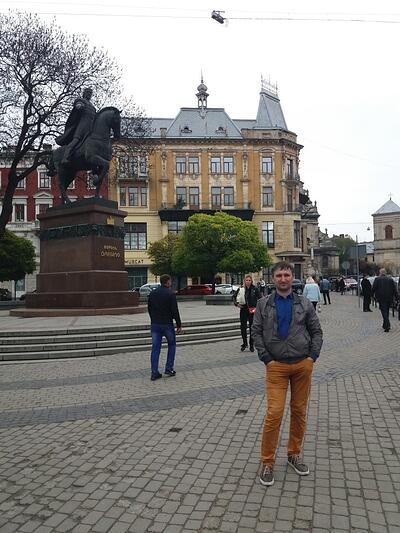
[0,294,400,533]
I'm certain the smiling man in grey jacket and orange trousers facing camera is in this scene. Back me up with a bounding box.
[253,261,322,486]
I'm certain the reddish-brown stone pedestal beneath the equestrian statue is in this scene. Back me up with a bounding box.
[19,198,141,316]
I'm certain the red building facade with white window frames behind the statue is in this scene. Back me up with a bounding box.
[0,150,108,298]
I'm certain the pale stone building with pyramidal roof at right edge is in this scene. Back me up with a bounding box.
[372,199,400,276]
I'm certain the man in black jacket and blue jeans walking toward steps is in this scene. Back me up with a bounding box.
[147,274,182,381]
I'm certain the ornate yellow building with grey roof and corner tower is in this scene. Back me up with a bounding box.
[110,81,319,288]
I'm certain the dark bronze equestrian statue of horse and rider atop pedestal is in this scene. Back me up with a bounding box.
[48,88,121,204]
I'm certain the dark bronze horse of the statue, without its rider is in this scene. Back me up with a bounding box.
[48,107,121,204]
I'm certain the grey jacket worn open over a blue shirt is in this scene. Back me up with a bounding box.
[251,292,322,364]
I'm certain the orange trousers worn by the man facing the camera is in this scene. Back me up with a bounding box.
[261,358,314,466]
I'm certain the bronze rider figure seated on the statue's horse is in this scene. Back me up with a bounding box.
[56,88,96,165]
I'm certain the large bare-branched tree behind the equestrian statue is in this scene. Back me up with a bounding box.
[0,12,149,233]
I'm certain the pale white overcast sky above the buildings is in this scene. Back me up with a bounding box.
[0,0,400,241]
